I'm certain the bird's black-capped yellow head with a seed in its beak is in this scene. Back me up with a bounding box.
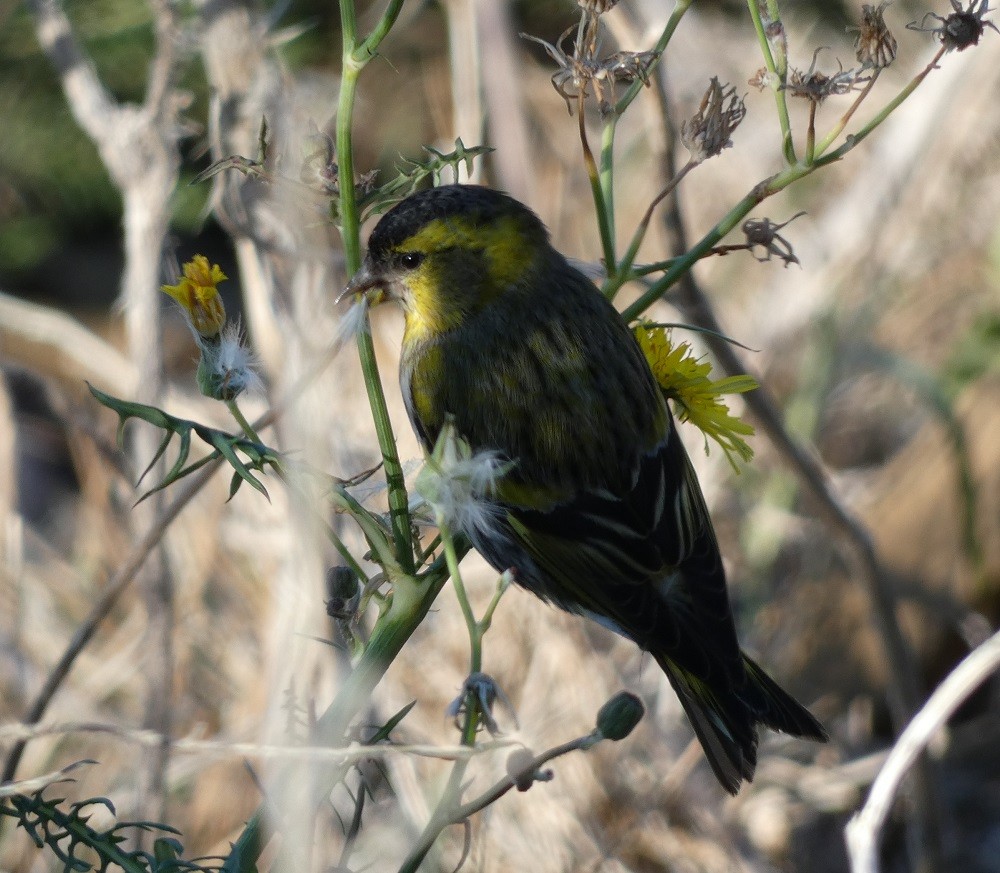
[345,185,551,339]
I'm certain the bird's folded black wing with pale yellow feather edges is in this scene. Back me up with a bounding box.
[501,421,744,687]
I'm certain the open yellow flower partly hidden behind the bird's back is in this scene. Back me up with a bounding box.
[635,324,757,472]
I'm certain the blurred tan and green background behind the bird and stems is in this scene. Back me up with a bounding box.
[0,0,1000,873]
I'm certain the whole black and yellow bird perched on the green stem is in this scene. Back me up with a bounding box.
[343,184,827,794]
